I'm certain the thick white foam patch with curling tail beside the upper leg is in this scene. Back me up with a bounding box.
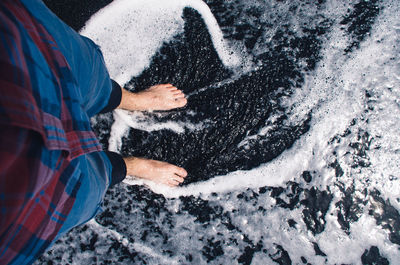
[81,0,240,84]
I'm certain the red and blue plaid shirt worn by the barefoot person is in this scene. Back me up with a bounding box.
[0,0,110,264]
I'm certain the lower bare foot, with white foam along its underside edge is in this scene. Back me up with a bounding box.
[124,157,187,187]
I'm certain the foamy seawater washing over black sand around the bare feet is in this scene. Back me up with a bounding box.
[37,0,400,264]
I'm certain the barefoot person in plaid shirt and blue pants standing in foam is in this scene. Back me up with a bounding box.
[0,0,187,264]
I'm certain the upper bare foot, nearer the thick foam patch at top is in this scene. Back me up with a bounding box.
[118,84,187,111]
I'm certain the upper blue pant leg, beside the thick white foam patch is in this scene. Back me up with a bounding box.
[21,0,113,117]
